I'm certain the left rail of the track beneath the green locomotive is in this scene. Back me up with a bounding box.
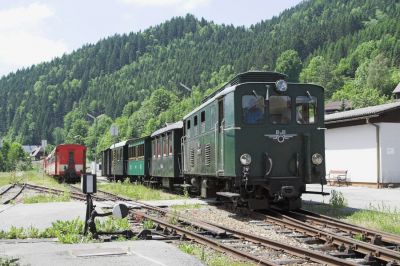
[264,210,400,263]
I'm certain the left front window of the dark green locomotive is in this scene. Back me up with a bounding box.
[242,95,265,124]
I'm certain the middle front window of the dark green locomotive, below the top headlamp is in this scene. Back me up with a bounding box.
[269,96,292,124]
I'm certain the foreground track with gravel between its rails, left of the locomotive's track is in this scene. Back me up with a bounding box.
[132,207,356,265]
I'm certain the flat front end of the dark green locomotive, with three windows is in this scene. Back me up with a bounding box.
[234,76,326,209]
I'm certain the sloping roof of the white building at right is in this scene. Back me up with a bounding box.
[325,102,400,124]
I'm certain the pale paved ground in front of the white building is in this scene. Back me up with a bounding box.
[302,184,400,210]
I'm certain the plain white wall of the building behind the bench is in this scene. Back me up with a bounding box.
[325,123,400,184]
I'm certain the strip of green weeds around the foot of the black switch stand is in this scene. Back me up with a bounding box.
[0,217,130,244]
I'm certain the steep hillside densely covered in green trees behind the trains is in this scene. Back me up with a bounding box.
[0,0,400,160]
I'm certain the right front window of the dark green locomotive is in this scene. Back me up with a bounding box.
[296,96,317,124]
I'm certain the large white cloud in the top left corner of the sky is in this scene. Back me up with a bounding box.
[0,3,68,75]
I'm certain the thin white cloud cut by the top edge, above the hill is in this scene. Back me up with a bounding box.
[121,0,210,11]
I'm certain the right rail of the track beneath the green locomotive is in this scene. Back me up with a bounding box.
[288,210,400,245]
